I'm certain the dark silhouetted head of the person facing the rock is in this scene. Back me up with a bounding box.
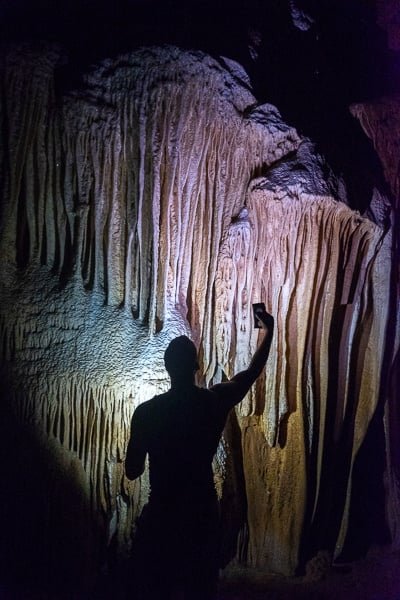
[164,335,199,380]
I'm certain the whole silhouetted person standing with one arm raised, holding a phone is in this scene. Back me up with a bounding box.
[125,313,274,600]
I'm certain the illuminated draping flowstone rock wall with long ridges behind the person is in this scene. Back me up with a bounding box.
[1,48,389,574]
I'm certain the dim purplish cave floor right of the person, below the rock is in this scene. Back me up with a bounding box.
[218,552,400,600]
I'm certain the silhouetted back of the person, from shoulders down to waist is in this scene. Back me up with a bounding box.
[138,385,229,504]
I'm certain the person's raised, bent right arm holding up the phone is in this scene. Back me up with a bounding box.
[211,312,274,406]
